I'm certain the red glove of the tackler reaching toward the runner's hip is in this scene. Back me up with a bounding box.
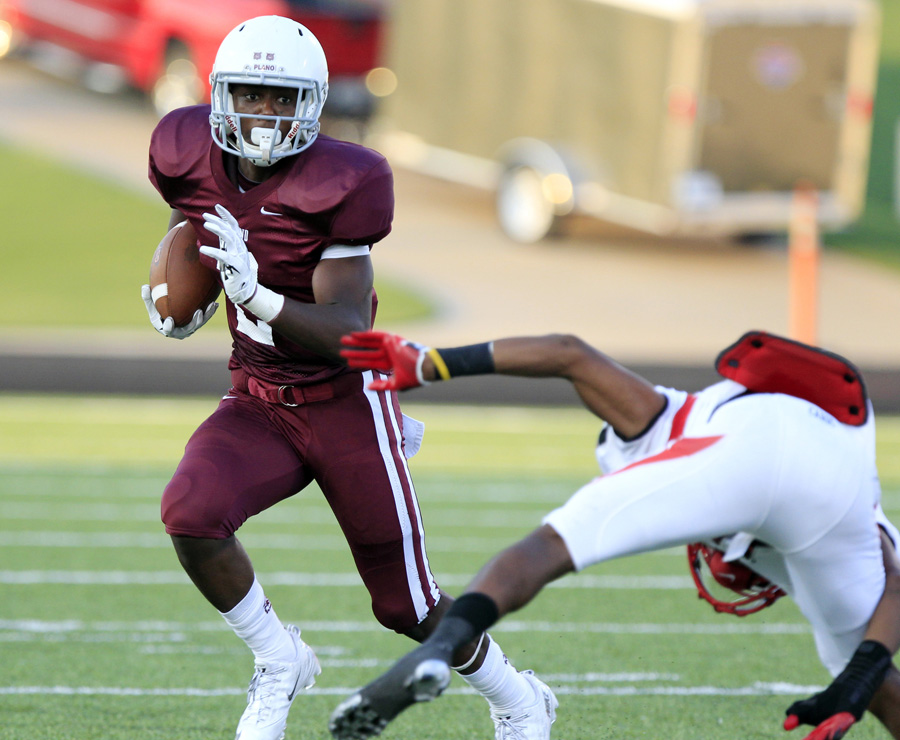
[341,331,429,391]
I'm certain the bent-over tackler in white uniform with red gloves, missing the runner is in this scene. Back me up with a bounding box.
[330,331,900,740]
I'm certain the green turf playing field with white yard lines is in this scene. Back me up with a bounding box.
[0,395,900,740]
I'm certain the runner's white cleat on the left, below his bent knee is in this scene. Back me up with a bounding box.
[235,624,322,740]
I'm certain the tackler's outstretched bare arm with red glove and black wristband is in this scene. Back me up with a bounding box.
[341,332,665,438]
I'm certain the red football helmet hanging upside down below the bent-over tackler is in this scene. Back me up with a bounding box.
[687,542,785,617]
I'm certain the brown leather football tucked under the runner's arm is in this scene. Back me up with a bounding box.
[150,221,219,326]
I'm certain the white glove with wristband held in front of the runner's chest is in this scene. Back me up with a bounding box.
[200,204,284,321]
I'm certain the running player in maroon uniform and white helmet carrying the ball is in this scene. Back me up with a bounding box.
[142,16,556,740]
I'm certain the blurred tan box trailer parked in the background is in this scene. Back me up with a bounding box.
[376,0,880,241]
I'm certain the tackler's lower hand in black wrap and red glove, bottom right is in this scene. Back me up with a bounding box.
[784,640,891,740]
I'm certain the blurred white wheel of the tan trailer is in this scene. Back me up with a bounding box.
[497,165,560,244]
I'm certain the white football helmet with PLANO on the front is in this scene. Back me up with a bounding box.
[209,15,328,167]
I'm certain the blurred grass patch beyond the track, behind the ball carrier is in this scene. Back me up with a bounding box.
[0,141,433,333]
